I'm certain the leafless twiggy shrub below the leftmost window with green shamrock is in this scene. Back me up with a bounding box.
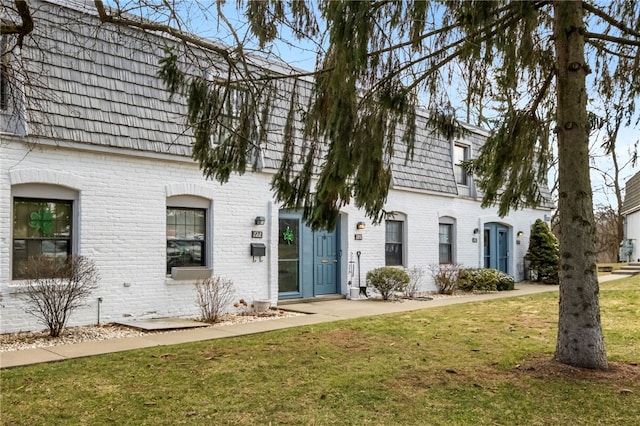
[20,256,100,337]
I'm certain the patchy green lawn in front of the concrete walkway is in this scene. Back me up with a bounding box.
[0,277,640,425]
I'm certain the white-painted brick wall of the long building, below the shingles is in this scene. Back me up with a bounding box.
[0,143,543,333]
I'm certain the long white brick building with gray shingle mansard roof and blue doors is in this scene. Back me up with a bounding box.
[0,0,550,333]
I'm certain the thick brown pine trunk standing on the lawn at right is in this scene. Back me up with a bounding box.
[554,0,607,369]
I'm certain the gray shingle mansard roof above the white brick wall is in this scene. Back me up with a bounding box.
[7,0,546,206]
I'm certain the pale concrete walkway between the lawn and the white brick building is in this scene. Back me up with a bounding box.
[0,275,624,368]
